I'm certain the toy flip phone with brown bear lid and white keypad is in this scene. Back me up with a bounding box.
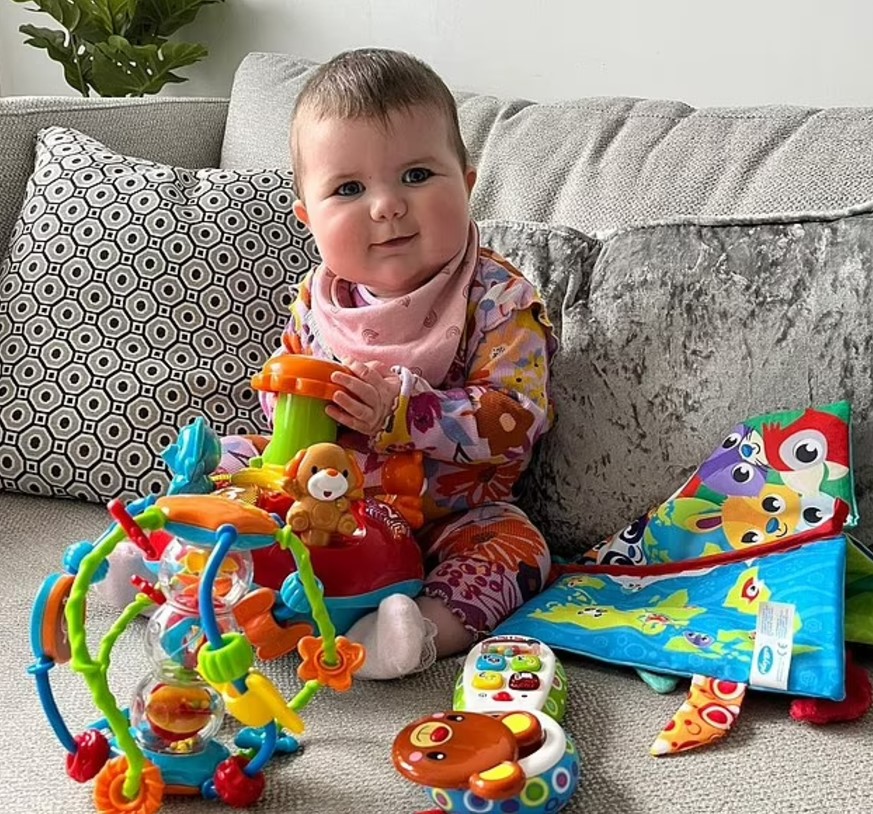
[392,635,579,814]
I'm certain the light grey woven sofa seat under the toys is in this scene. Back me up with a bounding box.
[10,494,873,814]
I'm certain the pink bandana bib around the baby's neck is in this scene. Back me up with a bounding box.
[311,222,479,387]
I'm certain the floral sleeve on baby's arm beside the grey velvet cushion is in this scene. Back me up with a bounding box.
[371,280,556,464]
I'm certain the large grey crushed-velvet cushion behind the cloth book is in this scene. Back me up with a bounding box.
[524,203,873,553]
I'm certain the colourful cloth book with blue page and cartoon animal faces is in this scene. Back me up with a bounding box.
[495,402,873,748]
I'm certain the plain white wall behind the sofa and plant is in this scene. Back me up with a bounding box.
[0,0,873,106]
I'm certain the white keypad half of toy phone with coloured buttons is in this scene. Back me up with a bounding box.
[454,636,567,720]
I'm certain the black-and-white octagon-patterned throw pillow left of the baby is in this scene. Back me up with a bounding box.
[0,127,318,501]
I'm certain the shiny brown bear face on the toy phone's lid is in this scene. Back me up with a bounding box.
[393,712,518,788]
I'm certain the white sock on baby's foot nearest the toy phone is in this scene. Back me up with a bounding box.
[346,594,436,679]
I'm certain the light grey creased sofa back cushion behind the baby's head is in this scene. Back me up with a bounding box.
[222,53,873,232]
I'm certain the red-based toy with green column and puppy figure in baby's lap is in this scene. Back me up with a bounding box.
[174,354,424,644]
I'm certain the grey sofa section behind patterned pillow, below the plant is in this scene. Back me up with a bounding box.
[0,97,227,262]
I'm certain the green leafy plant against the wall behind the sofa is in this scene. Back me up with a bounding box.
[14,0,223,96]
